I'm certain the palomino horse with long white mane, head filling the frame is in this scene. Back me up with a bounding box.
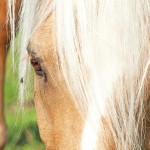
[5,0,150,150]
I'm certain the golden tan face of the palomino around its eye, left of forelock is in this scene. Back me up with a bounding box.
[29,16,83,150]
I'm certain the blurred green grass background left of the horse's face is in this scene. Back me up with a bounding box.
[4,49,45,150]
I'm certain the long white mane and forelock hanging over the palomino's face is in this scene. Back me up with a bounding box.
[8,0,150,150]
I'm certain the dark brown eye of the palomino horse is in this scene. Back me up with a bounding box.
[30,56,47,82]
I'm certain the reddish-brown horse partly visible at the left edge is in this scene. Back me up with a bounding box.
[0,0,20,149]
